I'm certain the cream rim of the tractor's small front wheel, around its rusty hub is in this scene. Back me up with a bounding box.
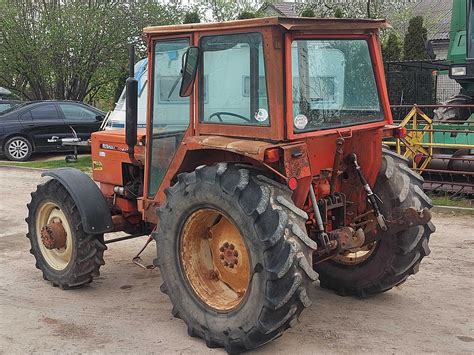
[36,201,74,271]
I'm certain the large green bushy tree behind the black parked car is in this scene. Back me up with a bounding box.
[0,0,180,101]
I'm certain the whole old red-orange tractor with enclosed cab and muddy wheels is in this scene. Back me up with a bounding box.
[27,18,434,352]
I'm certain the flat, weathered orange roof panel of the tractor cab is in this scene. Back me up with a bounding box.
[144,17,390,35]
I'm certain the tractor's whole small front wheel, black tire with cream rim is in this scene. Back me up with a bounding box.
[26,179,107,288]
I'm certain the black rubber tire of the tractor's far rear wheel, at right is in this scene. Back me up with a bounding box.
[315,148,435,297]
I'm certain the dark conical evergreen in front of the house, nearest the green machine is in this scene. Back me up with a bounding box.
[403,16,428,60]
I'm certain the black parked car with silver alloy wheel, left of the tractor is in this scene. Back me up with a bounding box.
[0,101,105,161]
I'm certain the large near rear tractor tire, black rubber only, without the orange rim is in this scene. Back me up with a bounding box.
[153,163,317,353]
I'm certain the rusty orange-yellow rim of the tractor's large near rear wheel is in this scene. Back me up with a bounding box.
[179,208,250,311]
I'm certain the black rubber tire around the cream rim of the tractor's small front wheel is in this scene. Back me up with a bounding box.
[26,179,107,289]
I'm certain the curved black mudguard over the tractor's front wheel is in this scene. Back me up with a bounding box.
[41,168,114,234]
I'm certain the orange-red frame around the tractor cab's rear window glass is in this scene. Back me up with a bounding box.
[285,33,392,139]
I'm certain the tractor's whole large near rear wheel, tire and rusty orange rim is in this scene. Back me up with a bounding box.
[154,163,317,353]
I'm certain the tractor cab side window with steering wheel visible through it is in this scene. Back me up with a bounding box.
[199,33,270,126]
